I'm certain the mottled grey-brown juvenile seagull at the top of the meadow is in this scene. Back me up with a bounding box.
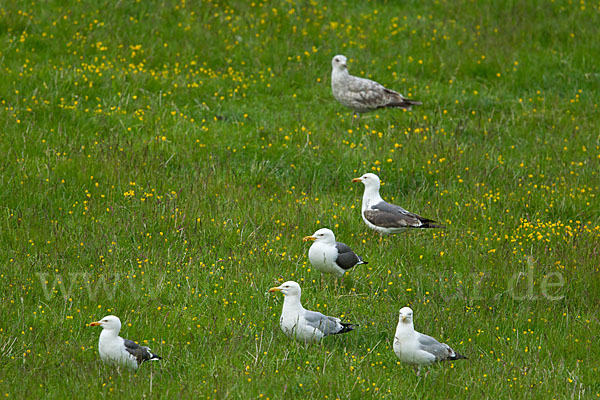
[331,55,422,115]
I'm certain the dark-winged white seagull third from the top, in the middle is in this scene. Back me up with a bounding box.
[302,228,368,282]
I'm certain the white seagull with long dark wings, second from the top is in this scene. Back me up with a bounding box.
[352,173,445,234]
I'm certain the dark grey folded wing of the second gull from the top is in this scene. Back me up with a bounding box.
[363,201,443,228]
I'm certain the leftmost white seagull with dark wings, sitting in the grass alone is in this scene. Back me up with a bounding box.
[90,315,161,369]
